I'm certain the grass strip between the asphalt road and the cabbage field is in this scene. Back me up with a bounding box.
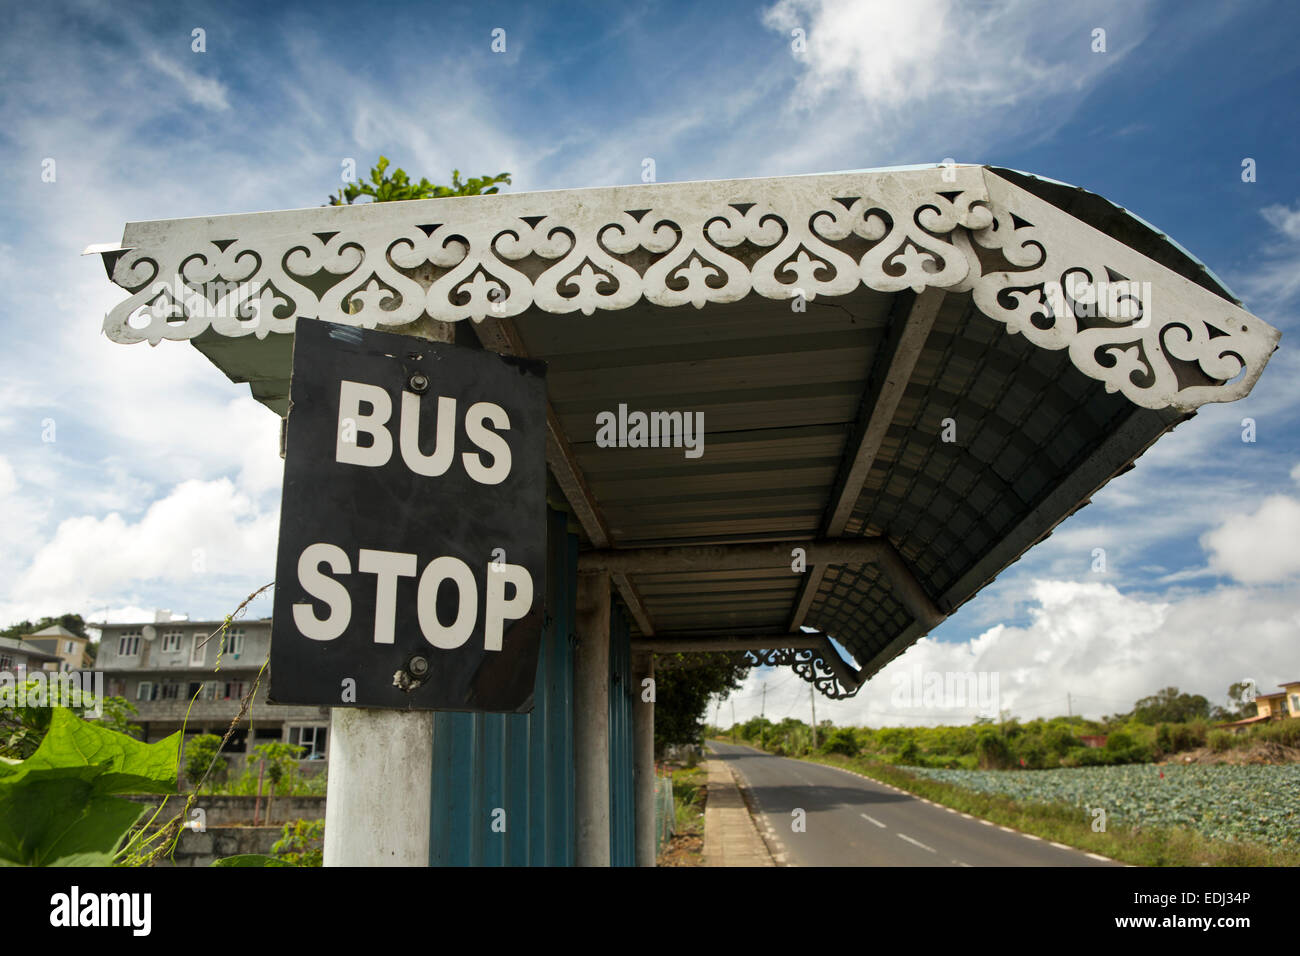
[750,744,1300,866]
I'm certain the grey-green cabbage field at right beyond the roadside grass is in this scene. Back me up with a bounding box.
[909,763,1300,845]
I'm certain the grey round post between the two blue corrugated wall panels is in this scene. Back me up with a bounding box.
[573,571,610,866]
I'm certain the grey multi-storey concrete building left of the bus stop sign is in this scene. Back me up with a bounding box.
[95,619,329,761]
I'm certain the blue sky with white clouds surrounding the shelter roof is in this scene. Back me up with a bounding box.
[0,0,1300,722]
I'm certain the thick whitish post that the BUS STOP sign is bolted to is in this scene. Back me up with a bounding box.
[324,319,456,866]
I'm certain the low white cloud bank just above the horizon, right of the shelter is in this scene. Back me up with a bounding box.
[728,580,1300,727]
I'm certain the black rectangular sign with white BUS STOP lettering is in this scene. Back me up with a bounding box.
[269,319,546,711]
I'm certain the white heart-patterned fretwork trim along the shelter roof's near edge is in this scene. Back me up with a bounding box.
[98,166,1279,410]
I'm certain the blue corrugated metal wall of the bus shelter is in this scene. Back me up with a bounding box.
[429,511,633,866]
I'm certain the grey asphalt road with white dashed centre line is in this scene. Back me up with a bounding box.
[710,743,1118,866]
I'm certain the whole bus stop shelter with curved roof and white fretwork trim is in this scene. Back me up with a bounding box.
[90,165,1279,865]
